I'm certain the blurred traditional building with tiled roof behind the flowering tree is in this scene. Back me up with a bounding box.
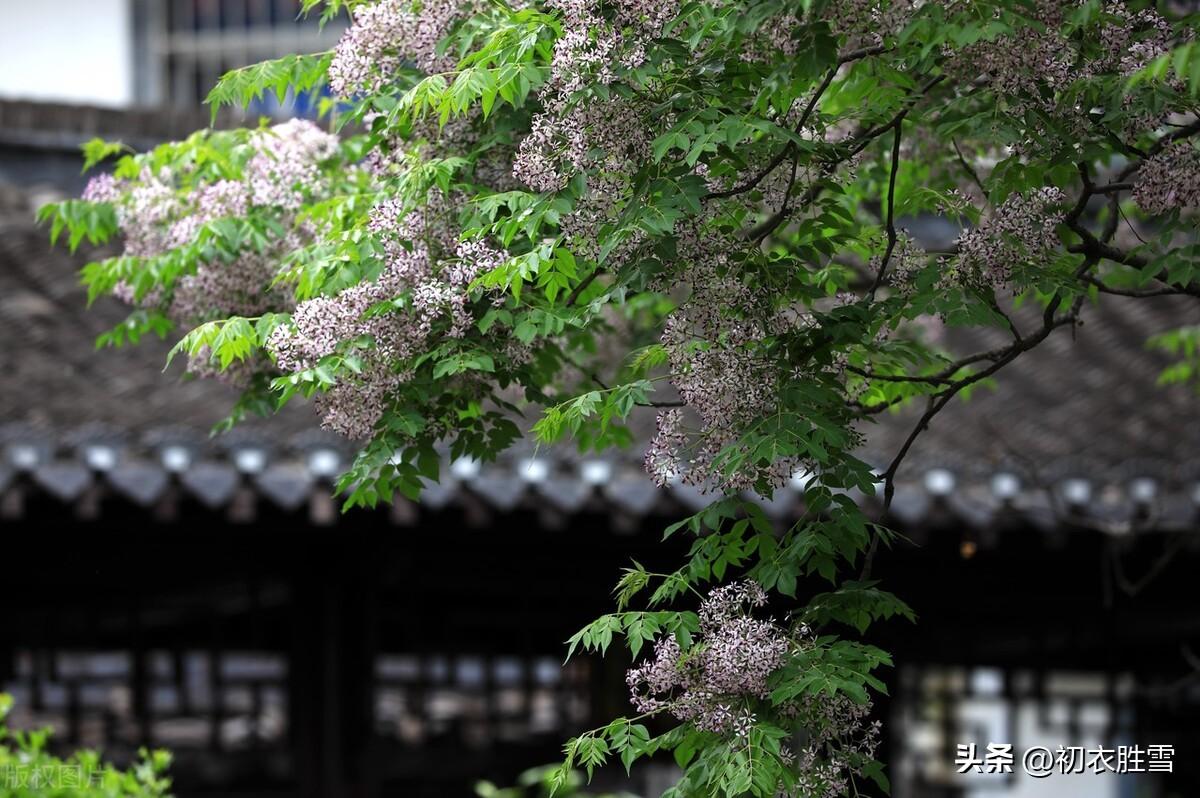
[0,0,1200,798]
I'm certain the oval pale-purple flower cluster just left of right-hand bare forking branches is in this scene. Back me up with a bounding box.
[950,187,1067,288]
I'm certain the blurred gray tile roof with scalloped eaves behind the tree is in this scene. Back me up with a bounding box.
[0,103,1200,529]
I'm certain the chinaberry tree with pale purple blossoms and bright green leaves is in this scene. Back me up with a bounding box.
[43,0,1200,797]
